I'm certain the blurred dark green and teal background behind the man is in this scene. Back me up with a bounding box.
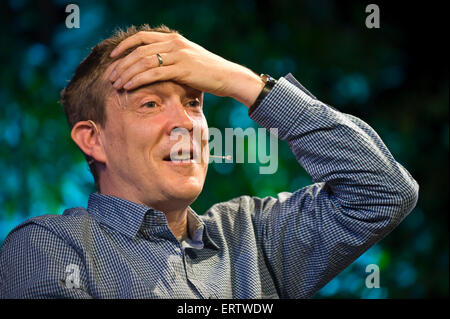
[0,0,449,298]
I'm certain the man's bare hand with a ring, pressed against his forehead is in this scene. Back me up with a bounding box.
[102,31,250,97]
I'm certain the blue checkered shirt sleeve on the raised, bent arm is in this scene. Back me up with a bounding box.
[246,74,418,298]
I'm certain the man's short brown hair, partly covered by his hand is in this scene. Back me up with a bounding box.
[60,24,178,190]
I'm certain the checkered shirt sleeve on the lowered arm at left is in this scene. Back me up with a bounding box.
[0,222,91,299]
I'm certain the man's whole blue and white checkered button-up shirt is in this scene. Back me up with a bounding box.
[0,74,418,298]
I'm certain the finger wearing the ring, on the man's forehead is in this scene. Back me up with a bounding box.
[113,53,176,89]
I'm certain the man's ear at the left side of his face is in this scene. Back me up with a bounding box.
[70,121,106,163]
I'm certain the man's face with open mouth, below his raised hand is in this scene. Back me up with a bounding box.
[102,82,209,211]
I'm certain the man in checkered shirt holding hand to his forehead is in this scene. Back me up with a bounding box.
[0,26,418,298]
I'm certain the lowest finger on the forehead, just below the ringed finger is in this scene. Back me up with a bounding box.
[123,64,179,90]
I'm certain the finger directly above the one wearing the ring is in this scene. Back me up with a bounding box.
[109,42,172,82]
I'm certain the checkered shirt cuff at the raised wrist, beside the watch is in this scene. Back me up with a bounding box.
[249,74,315,140]
